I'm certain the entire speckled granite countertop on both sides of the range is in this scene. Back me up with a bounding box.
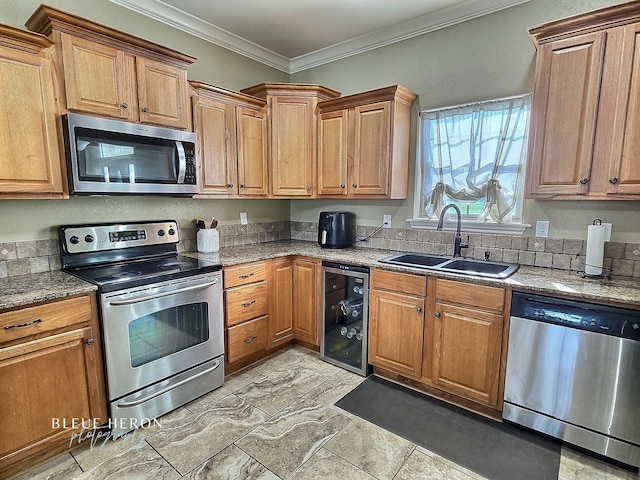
[0,240,640,310]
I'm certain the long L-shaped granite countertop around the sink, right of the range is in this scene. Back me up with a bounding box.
[185,240,640,308]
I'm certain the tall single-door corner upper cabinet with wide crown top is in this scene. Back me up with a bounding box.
[242,83,340,198]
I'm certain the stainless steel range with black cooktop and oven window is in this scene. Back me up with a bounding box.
[58,220,224,435]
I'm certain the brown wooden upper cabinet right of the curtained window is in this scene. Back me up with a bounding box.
[526,1,640,200]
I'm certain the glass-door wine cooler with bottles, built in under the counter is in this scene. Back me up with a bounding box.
[320,262,369,376]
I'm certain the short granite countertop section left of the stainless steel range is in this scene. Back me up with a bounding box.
[0,270,96,310]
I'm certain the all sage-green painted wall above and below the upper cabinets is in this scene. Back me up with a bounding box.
[0,0,640,243]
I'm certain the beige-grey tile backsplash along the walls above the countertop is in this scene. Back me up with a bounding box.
[5,221,640,278]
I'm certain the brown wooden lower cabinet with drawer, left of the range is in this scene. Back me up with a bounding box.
[0,293,107,478]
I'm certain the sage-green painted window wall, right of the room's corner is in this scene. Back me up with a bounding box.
[291,0,640,243]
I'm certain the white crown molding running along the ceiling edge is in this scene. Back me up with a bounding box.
[109,0,530,74]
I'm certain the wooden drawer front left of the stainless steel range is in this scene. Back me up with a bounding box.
[0,295,91,343]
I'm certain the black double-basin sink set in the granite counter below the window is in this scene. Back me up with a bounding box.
[378,253,520,278]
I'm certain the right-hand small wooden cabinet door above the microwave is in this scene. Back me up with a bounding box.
[136,57,191,129]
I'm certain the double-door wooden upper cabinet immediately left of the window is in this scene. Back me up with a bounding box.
[318,85,417,199]
